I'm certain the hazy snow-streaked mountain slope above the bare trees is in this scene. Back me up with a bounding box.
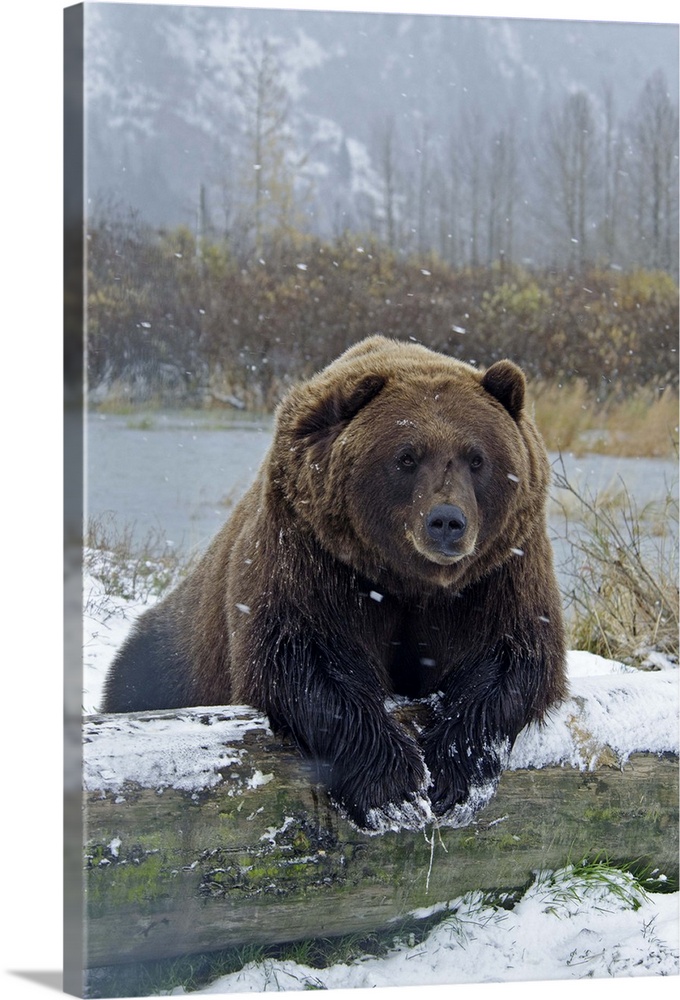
[86,4,678,231]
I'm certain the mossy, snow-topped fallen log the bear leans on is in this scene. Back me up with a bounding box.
[84,674,678,967]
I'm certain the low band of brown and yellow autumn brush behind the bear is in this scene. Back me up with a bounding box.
[87,218,678,410]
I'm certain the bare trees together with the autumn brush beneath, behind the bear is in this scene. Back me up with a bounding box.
[86,43,678,409]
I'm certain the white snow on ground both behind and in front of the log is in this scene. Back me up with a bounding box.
[83,575,680,995]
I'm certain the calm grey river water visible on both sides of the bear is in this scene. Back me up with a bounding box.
[85,412,678,577]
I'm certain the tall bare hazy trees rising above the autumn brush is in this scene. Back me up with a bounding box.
[197,58,679,275]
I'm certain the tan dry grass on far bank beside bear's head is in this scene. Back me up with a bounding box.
[530,381,678,458]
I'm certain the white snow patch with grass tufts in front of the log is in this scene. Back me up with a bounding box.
[175,871,678,995]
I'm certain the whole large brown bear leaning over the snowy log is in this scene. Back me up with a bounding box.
[104,336,565,831]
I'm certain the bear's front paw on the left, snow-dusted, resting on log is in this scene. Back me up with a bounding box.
[329,745,433,833]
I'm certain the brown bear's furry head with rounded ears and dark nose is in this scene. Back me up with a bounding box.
[272,336,548,589]
